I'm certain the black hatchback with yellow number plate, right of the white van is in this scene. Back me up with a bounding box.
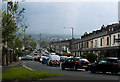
[61,58,89,71]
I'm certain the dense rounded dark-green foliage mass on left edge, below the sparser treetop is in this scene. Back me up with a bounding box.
[2,11,17,43]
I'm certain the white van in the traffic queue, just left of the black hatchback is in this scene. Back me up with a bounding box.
[47,55,60,66]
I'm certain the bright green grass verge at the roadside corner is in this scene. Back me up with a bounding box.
[2,67,62,80]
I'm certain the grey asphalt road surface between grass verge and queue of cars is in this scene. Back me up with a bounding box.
[23,61,120,80]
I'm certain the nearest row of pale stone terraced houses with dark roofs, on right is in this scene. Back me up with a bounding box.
[73,23,120,57]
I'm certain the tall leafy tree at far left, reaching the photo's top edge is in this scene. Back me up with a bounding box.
[2,1,25,62]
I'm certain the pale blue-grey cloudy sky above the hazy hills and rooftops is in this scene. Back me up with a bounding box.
[2,1,118,35]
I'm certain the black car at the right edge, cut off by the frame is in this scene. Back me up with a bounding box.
[90,57,120,74]
